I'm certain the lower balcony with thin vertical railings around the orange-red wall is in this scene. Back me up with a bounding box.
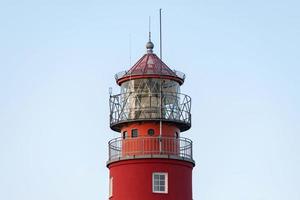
[107,137,195,164]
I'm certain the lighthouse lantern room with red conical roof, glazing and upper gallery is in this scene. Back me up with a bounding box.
[110,42,191,131]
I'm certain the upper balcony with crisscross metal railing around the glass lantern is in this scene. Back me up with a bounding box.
[109,92,191,132]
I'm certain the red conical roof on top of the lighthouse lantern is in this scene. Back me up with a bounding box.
[116,43,184,85]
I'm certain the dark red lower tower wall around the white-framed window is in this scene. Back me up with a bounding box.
[108,159,193,200]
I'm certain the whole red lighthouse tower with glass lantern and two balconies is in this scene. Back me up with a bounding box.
[107,36,195,200]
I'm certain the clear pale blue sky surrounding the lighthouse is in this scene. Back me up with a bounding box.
[0,0,300,200]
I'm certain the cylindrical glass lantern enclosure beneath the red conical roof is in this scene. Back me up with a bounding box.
[120,78,180,120]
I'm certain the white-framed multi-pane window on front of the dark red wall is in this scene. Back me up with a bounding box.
[152,172,168,193]
